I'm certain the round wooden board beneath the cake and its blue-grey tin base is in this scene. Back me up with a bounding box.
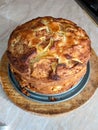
[0,50,98,115]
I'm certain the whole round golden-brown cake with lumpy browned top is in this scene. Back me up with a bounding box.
[7,17,91,93]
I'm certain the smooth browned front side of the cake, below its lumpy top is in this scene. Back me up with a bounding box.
[12,66,86,94]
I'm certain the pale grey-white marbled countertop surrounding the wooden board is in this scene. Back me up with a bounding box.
[0,0,98,130]
